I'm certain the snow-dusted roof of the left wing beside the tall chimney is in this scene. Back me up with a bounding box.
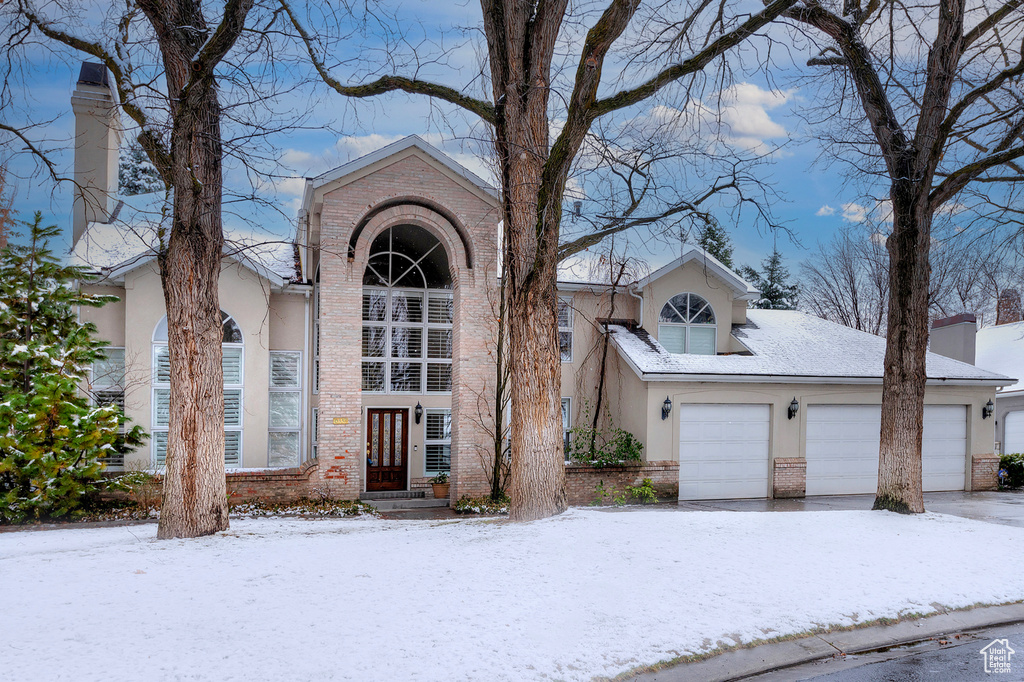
[68,193,300,286]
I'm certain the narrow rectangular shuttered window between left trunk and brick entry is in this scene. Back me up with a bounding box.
[267,350,302,467]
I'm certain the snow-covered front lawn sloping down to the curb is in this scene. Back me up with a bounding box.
[0,510,1024,681]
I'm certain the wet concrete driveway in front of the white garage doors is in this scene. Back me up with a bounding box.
[679,491,1024,527]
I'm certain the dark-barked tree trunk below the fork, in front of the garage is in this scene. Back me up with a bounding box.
[873,183,932,514]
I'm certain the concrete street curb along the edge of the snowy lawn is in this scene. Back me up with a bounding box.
[615,601,1024,682]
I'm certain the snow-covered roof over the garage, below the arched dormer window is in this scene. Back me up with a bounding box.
[609,309,1012,386]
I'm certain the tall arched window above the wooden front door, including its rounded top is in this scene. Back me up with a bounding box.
[362,225,453,393]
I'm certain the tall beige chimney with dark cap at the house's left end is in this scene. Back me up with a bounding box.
[71,61,121,247]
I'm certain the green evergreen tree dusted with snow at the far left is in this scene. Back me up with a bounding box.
[0,212,145,522]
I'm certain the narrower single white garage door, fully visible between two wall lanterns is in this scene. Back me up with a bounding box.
[679,404,769,500]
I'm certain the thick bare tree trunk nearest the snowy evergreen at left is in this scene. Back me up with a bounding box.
[140,0,239,538]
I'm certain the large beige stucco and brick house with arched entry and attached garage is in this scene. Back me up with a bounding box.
[72,63,1009,502]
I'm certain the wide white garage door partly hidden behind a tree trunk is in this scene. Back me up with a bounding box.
[807,404,967,495]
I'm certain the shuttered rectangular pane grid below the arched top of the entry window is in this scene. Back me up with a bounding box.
[362,288,452,393]
